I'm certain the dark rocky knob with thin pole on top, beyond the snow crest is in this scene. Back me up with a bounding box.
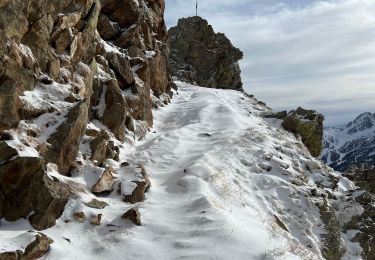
[169,16,243,90]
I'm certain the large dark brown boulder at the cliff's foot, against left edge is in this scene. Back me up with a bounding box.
[0,154,69,230]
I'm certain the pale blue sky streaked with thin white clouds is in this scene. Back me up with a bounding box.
[165,0,375,126]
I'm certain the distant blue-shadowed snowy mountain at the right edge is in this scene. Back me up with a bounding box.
[322,112,375,171]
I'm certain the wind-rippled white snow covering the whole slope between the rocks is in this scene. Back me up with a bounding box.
[0,82,361,260]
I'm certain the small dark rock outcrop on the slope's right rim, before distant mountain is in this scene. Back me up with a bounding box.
[264,107,324,157]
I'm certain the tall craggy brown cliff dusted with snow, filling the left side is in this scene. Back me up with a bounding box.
[0,0,173,229]
